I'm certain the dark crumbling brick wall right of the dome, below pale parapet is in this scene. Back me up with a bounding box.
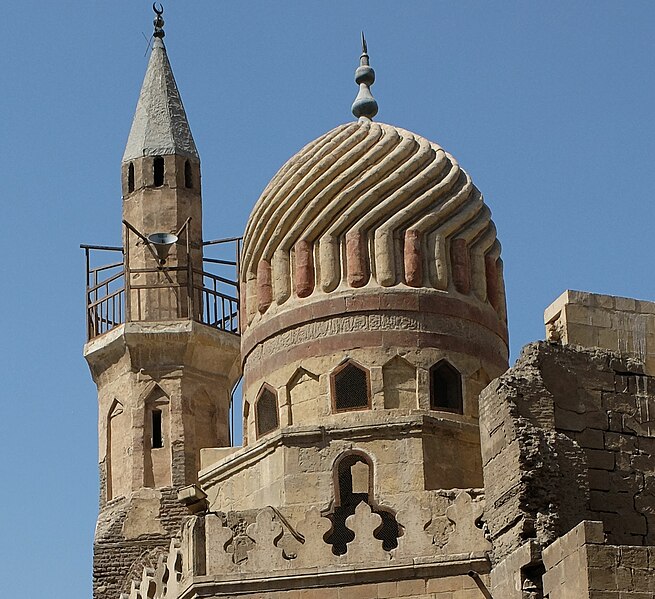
[480,342,655,562]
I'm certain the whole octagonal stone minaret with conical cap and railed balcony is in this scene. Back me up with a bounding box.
[84,9,240,599]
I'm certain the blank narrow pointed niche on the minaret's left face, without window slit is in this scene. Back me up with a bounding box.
[105,399,132,501]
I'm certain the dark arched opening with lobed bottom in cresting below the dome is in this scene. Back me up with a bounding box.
[325,451,402,555]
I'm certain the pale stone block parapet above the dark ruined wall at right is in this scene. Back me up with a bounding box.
[544,290,655,376]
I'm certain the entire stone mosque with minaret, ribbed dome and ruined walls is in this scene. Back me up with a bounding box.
[84,5,655,599]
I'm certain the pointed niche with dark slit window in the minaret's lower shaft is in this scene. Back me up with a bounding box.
[143,385,172,489]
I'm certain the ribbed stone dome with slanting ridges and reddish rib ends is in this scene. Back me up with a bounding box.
[241,119,505,330]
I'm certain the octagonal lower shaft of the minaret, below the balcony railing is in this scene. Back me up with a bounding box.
[85,320,240,598]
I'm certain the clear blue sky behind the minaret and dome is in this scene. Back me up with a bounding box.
[0,0,655,599]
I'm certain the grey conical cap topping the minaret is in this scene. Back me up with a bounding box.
[123,9,199,162]
